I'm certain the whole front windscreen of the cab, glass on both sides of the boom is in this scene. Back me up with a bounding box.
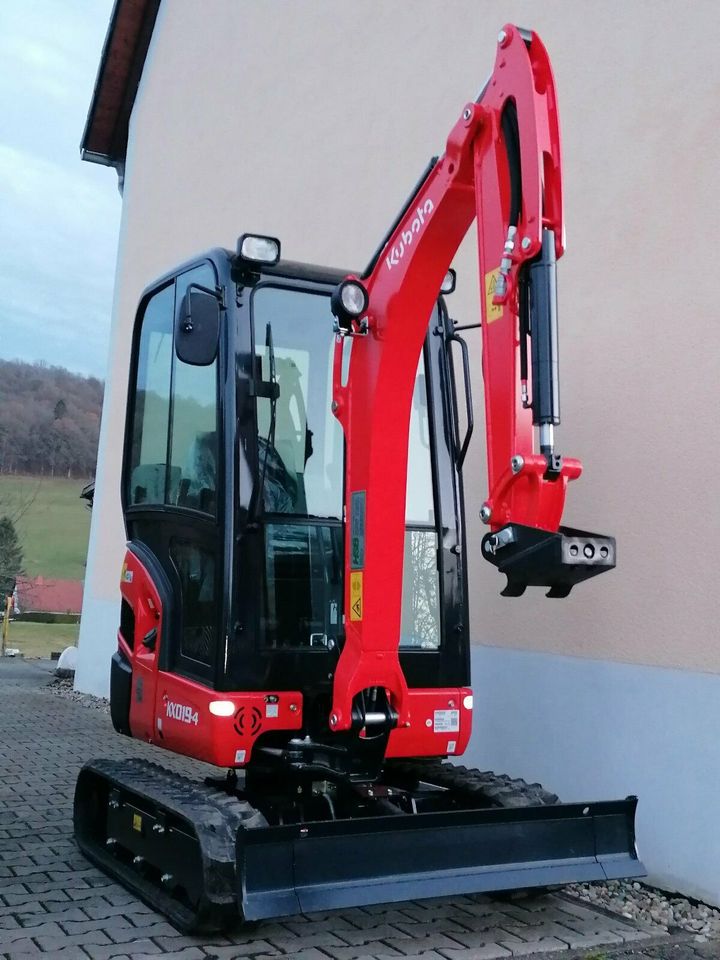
[252,285,440,650]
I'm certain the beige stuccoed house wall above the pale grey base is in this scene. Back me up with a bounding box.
[81,0,720,686]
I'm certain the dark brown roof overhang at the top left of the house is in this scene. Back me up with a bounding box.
[80,0,160,180]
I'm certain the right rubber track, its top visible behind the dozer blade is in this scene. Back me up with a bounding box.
[385,760,560,808]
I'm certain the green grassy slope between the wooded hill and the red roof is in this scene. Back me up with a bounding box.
[0,476,90,576]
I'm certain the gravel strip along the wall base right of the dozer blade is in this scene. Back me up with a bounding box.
[563,880,720,941]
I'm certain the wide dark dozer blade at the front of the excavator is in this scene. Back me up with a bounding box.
[237,797,645,920]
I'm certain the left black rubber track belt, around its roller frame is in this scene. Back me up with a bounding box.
[75,759,267,932]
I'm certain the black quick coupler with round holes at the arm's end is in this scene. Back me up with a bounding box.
[482,523,616,597]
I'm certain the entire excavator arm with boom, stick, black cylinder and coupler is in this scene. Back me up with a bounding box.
[330,25,615,730]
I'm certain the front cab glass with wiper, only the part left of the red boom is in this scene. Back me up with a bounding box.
[252,285,343,649]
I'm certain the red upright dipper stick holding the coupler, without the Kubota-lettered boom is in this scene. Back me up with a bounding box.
[473,26,582,531]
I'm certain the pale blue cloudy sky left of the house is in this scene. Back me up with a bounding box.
[0,0,120,378]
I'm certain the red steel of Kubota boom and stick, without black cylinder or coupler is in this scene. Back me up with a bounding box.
[330,26,580,730]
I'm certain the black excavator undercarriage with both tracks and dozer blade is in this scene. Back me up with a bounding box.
[75,760,644,932]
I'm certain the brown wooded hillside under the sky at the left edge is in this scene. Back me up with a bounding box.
[0,360,103,480]
